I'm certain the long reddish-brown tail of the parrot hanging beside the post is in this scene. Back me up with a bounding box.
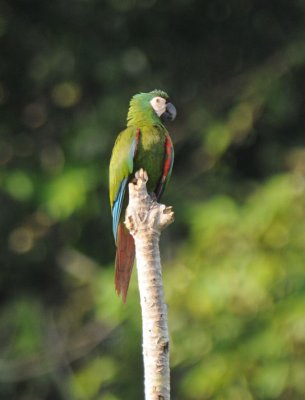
[115,223,135,303]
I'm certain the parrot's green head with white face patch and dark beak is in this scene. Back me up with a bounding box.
[127,89,177,123]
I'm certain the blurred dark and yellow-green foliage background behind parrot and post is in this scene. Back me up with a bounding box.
[0,0,305,400]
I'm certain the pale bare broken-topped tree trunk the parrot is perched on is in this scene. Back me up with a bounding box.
[125,169,174,400]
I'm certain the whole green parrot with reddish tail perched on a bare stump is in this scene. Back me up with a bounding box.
[109,90,176,303]
